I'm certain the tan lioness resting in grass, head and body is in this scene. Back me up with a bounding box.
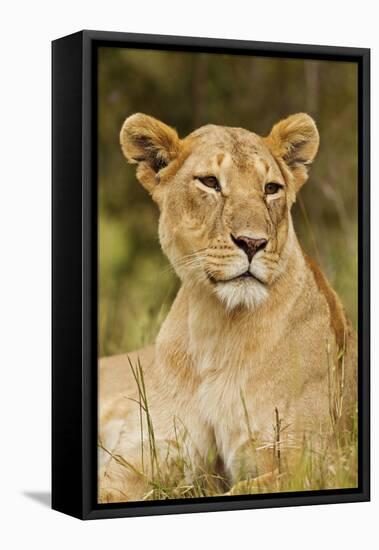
[99,113,356,502]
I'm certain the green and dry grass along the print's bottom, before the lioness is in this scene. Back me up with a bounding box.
[101,354,358,500]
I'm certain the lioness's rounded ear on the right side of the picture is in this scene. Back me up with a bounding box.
[266,113,320,191]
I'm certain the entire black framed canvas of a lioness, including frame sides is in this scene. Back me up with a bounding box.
[52,31,370,519]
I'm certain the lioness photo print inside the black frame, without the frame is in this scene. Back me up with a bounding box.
[97,47,359,504]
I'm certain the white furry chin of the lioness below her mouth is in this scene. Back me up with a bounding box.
[215,279,268,310]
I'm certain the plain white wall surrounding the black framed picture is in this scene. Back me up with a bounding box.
[0,0,379,550]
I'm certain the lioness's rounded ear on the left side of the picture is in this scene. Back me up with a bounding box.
[120,113,180,192]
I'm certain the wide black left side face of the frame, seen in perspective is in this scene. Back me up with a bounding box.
[52,33,83,518]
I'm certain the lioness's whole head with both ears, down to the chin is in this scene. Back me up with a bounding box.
[121,114,319,309]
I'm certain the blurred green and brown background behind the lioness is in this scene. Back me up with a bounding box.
[98,48,358,356]
